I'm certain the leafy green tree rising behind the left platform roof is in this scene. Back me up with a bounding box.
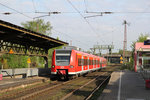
[21,19,52,35]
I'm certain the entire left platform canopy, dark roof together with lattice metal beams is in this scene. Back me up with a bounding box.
[0,20,68,65]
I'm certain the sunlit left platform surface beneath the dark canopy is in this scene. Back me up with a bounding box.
[0,76,49,92]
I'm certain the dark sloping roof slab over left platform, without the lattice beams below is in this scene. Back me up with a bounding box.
[0,20,68,49]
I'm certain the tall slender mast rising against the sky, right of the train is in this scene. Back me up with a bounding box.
[123,20,129,63]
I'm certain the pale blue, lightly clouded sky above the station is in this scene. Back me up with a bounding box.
[0,0,150,52]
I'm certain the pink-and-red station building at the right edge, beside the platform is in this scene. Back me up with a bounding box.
[134,38,150,72]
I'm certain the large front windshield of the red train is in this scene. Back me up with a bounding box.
[56,50,71,66]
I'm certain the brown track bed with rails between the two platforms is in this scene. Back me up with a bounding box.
[0,65,120,100]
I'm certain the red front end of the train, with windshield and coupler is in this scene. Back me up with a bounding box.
[51,49,74,79]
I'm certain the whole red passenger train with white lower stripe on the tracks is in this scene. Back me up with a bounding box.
[51,49,106,78]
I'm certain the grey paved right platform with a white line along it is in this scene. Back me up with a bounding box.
[98,71,150,100]
